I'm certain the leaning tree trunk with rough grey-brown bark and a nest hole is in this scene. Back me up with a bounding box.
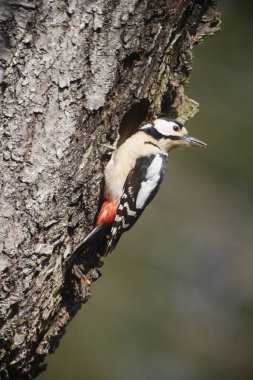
[0,0,219,379]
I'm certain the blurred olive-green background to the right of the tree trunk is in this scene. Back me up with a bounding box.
[39,0,253,380]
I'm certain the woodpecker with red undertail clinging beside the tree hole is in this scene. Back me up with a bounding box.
[77,117,206,256]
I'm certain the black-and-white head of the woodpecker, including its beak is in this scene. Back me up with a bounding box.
[141,116,206,152]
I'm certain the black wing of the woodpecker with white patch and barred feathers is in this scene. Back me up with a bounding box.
[105,153,168,254]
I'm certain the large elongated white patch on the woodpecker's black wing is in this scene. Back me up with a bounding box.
[136,156,163,209]
